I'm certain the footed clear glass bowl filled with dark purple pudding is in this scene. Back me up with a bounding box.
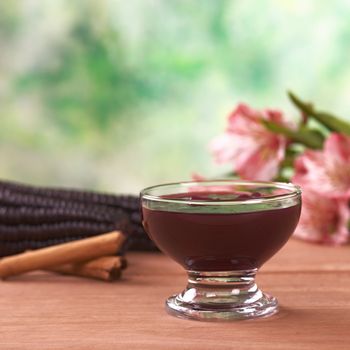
[141,180,301,321]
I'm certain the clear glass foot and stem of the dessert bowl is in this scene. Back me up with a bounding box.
[166,269,278,321]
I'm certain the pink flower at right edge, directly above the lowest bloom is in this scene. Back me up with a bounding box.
[293,133,350,198]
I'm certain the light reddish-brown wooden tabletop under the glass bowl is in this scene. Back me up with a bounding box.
[0,240,350,350]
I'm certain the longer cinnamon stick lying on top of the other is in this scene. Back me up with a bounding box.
[0,231,125,278]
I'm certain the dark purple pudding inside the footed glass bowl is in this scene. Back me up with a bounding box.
[142,190,301,271]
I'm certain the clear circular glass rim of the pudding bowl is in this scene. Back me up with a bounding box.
[140,179,302,206]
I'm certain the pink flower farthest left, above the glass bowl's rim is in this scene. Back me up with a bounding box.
[210,104,287,181]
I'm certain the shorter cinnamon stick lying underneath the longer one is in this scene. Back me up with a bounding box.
[47,256,126,282]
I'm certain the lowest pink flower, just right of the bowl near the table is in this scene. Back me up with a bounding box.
[294,189,350,245]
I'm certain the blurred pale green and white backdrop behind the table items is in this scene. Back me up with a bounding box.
[0,0,350,193]
